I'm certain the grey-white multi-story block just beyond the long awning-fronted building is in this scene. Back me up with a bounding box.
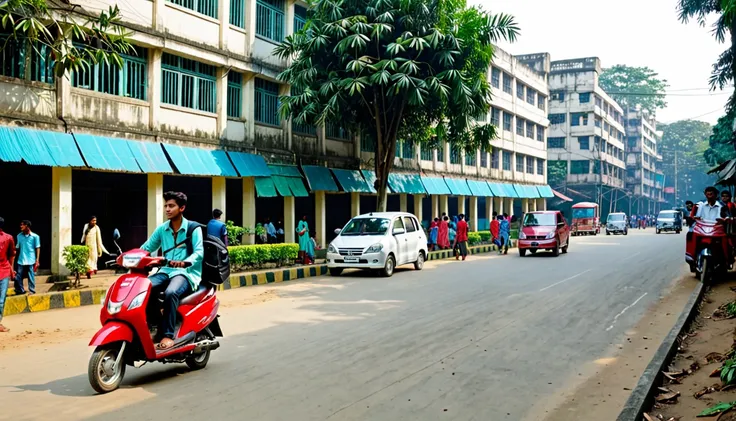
[547,57,626,210]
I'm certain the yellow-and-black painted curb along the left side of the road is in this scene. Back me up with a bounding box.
[4,241,515,317]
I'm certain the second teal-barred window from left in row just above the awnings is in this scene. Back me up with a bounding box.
[72,47,148,100]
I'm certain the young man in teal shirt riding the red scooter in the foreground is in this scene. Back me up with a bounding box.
[141,191,204,349]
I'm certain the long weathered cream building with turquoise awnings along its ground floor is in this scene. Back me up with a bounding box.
[0,0,551,272]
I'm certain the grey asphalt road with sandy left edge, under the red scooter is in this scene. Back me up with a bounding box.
[0,230,685,421]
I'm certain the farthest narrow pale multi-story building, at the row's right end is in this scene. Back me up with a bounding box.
[626,109,664,214]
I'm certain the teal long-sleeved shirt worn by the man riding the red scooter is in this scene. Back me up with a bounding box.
[141,218,204,291]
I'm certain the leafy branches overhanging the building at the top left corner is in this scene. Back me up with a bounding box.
[0,0,135,78]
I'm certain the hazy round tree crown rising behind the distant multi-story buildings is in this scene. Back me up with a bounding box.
[599,64,669,114]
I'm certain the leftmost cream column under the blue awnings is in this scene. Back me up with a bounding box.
[51,167,72,275]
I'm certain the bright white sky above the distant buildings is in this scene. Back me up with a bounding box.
[468,0,732,124]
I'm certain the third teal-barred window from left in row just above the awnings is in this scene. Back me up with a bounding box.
[161,53,217,113]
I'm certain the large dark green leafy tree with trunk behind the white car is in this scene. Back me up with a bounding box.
[275,0,519,210]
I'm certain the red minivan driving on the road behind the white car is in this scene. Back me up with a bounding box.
[517,211,570,257]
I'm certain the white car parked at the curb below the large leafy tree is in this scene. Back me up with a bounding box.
[327,212,427,277]
